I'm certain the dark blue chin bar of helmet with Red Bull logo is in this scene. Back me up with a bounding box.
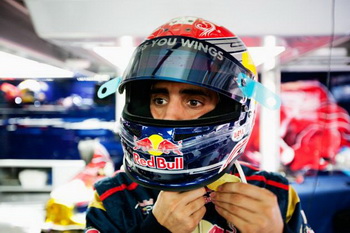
[121,115,251,191]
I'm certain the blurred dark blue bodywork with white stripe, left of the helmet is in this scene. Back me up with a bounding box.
[0,78,123,167]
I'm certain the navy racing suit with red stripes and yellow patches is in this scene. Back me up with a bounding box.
[85,163,313,233]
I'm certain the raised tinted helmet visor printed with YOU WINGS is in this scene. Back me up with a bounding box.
[119,36,253,104]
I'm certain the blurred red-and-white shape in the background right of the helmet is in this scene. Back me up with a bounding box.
[242,81,350,172]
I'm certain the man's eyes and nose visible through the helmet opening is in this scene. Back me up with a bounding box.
[150,81,219,120]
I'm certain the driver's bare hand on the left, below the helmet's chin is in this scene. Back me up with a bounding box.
[152,188,206,233]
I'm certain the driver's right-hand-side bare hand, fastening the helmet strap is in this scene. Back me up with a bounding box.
[210,183,283,233]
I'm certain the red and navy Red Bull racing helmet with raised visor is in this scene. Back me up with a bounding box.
[119,17,256,191]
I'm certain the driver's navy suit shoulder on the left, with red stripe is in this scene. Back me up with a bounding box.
[87,171,157,232]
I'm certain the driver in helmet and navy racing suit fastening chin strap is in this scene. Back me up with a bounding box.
[86,17,311,233]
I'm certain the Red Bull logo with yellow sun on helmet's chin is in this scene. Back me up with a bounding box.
[133,134,184,170]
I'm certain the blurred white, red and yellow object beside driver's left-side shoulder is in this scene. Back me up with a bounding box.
[42,140,114,232]
